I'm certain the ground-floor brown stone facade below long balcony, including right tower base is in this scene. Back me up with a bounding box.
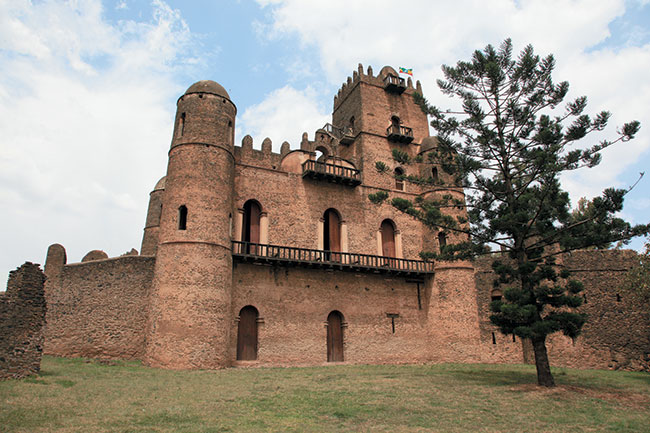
[231,263,477,365]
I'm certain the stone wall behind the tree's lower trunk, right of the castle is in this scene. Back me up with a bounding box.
[475,250,650,371]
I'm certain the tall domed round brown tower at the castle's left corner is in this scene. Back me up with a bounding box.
[145,81,237,368]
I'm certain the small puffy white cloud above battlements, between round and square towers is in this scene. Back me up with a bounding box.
[237,86,330,152]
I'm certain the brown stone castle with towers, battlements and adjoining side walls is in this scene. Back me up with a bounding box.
[38,65,650,369]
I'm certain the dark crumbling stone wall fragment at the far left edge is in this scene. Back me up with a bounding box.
[0,262,46,379]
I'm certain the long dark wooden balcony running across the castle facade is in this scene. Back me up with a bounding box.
[232,241,434,277]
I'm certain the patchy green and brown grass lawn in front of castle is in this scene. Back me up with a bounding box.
[0,357,650,433]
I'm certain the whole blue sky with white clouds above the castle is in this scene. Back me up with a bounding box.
[0,0,650,290]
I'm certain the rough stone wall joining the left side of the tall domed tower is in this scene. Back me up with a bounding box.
[45,256,155,359]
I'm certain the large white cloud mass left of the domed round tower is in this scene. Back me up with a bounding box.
[0,0,196,286]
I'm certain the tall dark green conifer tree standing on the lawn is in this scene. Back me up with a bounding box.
[372,39,649,386]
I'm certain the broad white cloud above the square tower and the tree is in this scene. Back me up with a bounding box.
[253,0,650,235]
